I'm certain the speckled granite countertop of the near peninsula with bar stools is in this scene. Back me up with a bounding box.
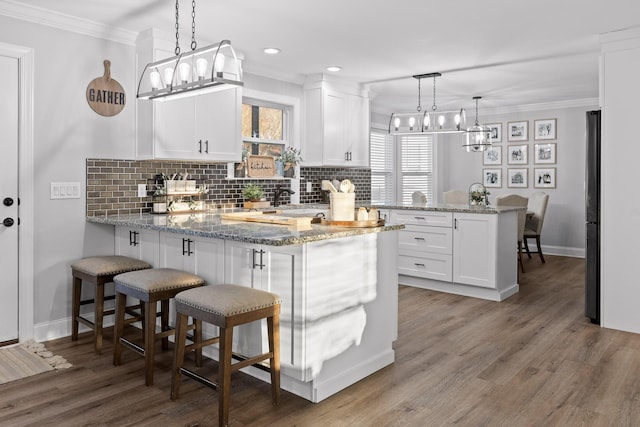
[87,205,404,246]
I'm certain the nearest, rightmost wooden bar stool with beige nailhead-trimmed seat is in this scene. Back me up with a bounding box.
[171,285,281,426]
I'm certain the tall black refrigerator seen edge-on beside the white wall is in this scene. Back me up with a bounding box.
[584,111,601,325]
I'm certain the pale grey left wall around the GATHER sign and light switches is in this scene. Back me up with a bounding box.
[0,16,137,339]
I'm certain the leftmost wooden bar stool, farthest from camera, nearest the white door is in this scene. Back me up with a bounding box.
[71,255,151,354]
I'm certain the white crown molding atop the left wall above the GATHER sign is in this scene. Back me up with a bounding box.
[0,0,138,46]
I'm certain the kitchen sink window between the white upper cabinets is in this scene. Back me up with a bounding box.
[242,99,289,157]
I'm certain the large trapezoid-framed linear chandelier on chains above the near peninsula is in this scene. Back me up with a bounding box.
[137,0,244,101]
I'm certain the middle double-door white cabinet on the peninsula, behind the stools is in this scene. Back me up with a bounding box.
[159,232,224,285]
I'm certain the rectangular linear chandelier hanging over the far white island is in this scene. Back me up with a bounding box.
[389,73,467,135]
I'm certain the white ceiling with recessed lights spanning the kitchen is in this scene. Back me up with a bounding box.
[7,0,640,112]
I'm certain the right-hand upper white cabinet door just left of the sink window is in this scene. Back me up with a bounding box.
[194,88,242,162]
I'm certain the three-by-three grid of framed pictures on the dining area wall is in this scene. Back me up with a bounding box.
[482,119,558,188]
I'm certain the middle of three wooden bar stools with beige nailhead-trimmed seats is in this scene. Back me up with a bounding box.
[113,268,204,386]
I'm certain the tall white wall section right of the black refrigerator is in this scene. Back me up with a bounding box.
[600,28,640,333]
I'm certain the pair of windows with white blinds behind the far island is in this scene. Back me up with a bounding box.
[370,129,435,204]
